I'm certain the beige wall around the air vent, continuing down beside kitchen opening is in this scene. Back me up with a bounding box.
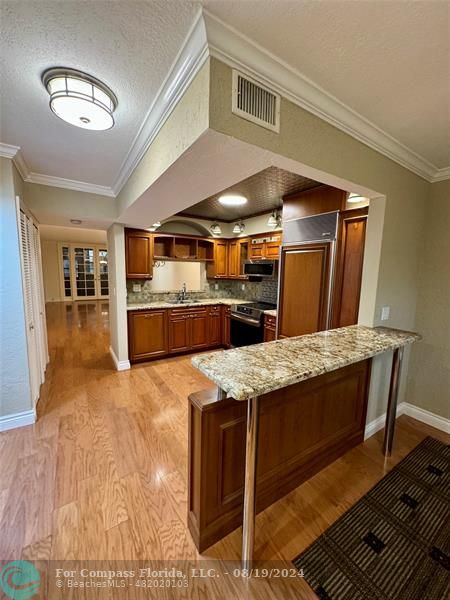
[210,60,432,421]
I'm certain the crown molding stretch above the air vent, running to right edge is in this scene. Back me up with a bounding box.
[203,10,447,181]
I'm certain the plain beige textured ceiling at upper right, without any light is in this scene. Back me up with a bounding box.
[202,0,450,168]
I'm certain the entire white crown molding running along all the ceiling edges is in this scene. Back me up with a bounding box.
[0,9,450,198]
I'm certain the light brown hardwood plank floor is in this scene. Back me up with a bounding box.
[0,302,448,598]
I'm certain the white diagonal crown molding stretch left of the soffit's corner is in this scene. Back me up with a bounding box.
[113,10,209,196]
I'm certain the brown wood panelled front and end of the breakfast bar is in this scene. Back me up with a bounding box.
[188,359,371,552]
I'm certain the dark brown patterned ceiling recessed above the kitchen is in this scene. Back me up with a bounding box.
[178,167,320,223]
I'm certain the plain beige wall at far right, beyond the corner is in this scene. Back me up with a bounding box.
[406,181,450,419]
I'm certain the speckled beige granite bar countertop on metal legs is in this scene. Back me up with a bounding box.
[192,325,420,400]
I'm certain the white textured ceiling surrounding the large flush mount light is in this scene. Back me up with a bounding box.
[0,0,198,186]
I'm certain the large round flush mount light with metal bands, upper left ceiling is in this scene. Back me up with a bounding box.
[42,67,117,131]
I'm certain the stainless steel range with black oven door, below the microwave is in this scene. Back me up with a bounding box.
[230,302,277,346]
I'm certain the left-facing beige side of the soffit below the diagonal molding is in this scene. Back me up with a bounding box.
[117,61,210,215]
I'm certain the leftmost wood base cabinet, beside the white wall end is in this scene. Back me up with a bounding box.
[128,310,168,362]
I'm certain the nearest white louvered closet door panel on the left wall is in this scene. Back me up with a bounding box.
[20,211,41,404]
